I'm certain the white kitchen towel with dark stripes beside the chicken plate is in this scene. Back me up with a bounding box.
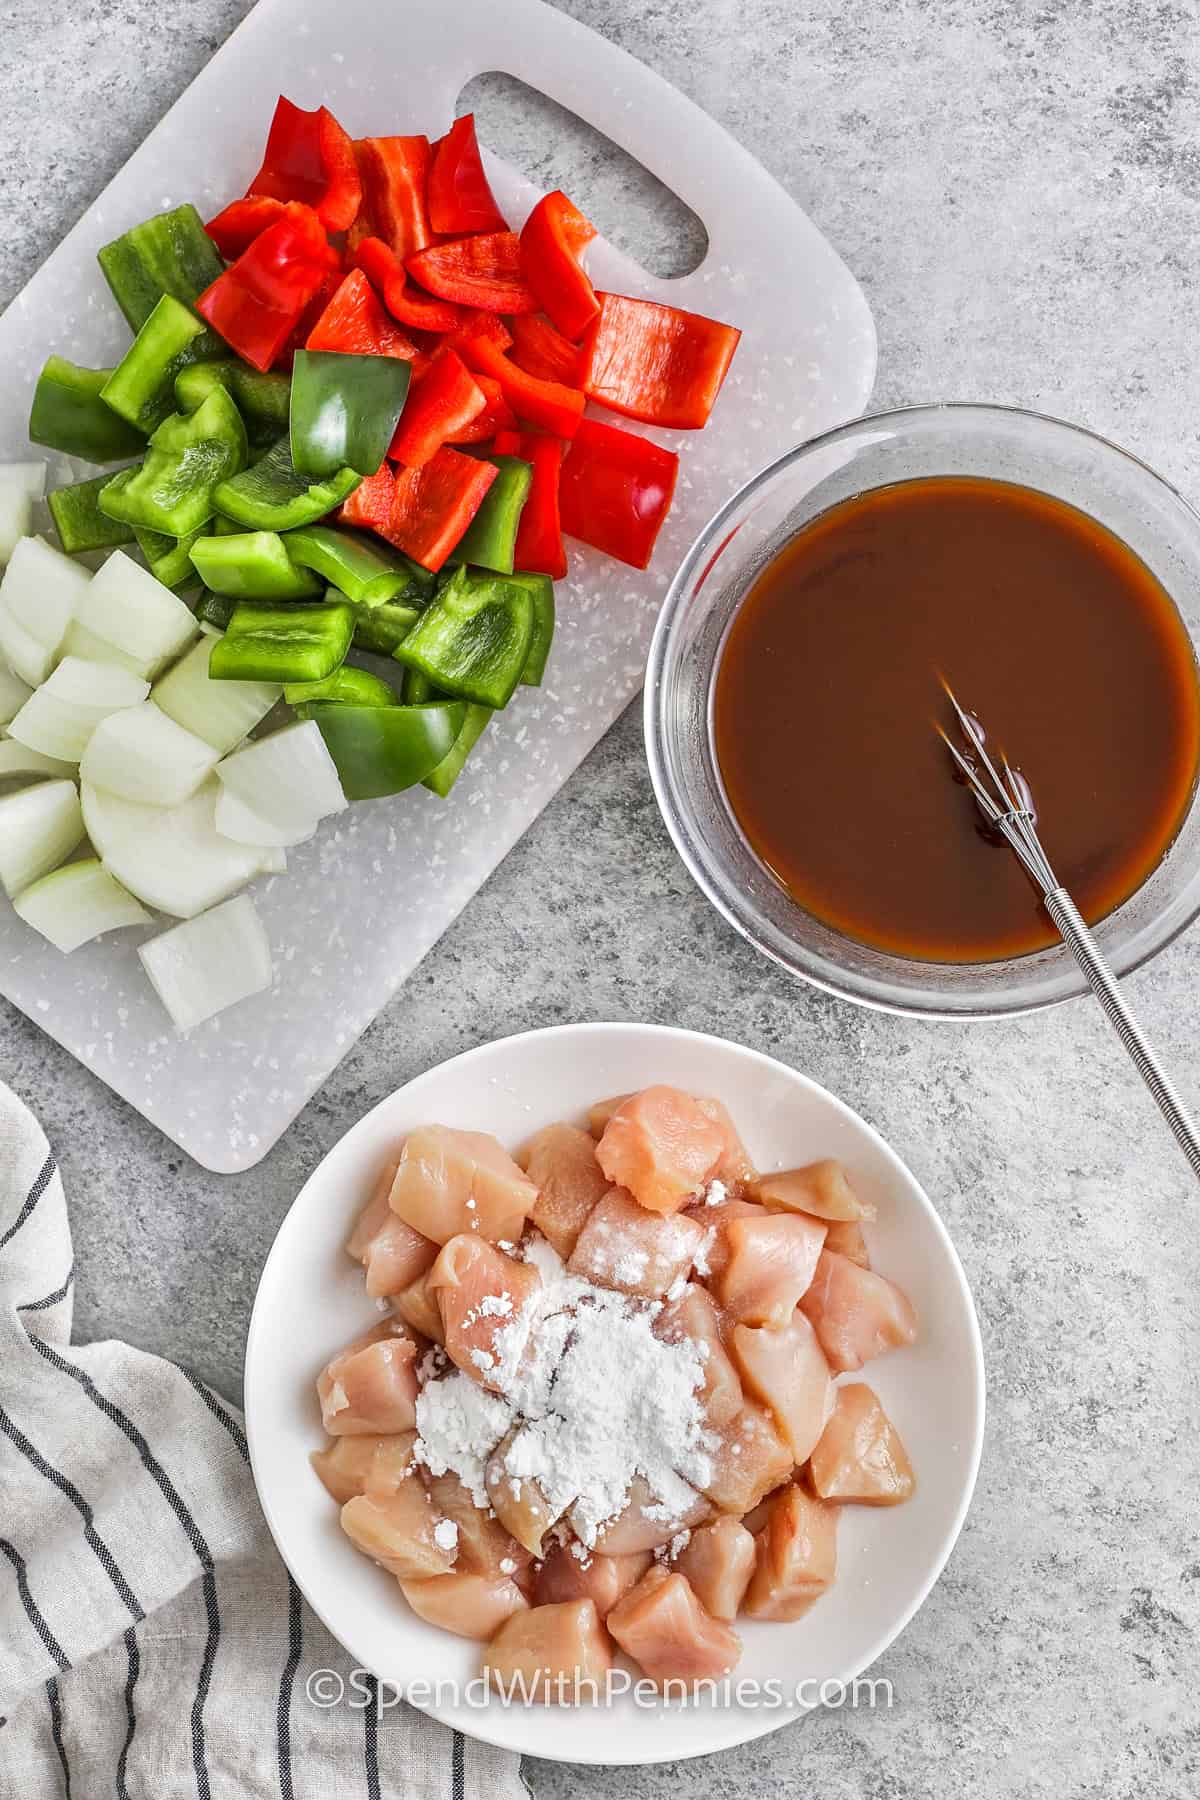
[0,1084,525,1800]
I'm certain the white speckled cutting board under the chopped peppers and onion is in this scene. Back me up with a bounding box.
[0,0,874,1172]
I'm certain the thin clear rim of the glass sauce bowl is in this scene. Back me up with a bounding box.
[642,400,1200,1022]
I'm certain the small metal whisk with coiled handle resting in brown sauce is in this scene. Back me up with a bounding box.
[937,682,1200,1181]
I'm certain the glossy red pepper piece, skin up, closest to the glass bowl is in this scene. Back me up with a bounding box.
[558,419,678,569]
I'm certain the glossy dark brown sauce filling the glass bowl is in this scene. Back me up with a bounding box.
[712,477,1200,963]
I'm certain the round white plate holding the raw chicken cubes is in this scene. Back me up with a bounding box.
[246,1024,984,1764]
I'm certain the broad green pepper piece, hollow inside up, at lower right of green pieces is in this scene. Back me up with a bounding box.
[394,569,533,707]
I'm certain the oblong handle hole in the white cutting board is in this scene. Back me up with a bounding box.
[455,70,709,281]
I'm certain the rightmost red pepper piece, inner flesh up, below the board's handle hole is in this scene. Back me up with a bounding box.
[583,293,741,430]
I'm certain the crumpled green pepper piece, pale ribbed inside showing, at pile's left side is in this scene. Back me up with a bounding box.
[101,387,246,538]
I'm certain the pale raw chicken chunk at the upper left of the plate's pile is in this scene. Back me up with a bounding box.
[390,1125,538,1244]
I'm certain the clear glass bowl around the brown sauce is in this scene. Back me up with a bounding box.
[644,405,1200,1019]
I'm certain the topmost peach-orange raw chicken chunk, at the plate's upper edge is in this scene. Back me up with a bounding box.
[596,1087,725,1213]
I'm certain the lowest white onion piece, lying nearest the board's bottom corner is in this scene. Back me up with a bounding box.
[137,895,273,1031]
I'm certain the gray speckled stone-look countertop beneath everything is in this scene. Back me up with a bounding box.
[0,0,1200,1800]
